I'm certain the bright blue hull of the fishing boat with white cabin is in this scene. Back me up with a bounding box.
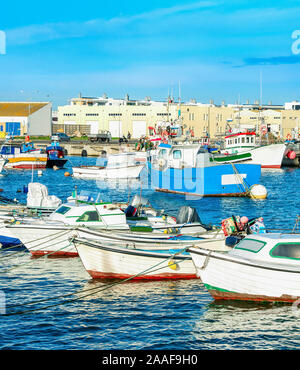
[149,163,261,196]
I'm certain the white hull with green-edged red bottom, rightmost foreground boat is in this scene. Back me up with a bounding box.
[188,248,300,302]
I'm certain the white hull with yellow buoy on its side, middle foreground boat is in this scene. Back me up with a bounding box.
[74,239,197,280]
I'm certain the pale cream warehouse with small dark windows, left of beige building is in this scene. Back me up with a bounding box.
[53,95,178,138]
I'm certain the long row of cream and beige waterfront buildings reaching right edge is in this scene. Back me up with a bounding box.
[52,95,300,140]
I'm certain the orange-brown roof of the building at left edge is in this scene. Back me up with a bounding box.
[0,102,48,117]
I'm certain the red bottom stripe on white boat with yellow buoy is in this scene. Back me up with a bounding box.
[87,270,198,280]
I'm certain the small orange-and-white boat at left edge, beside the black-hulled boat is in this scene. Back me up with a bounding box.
[0,136,47,169]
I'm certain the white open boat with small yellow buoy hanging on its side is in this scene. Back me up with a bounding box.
[73,233,229,279]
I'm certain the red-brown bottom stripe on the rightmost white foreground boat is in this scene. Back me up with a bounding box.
[209,290,299,303]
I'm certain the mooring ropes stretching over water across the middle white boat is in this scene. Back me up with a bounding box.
[3,248,190,316]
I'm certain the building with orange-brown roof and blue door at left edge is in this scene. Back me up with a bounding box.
[0,102,52,137]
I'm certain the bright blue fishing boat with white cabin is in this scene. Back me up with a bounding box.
[148,144,261,196]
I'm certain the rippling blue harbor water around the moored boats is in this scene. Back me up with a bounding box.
[0,157,300,350]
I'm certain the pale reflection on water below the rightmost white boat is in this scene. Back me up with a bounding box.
[193,301,300,349]
